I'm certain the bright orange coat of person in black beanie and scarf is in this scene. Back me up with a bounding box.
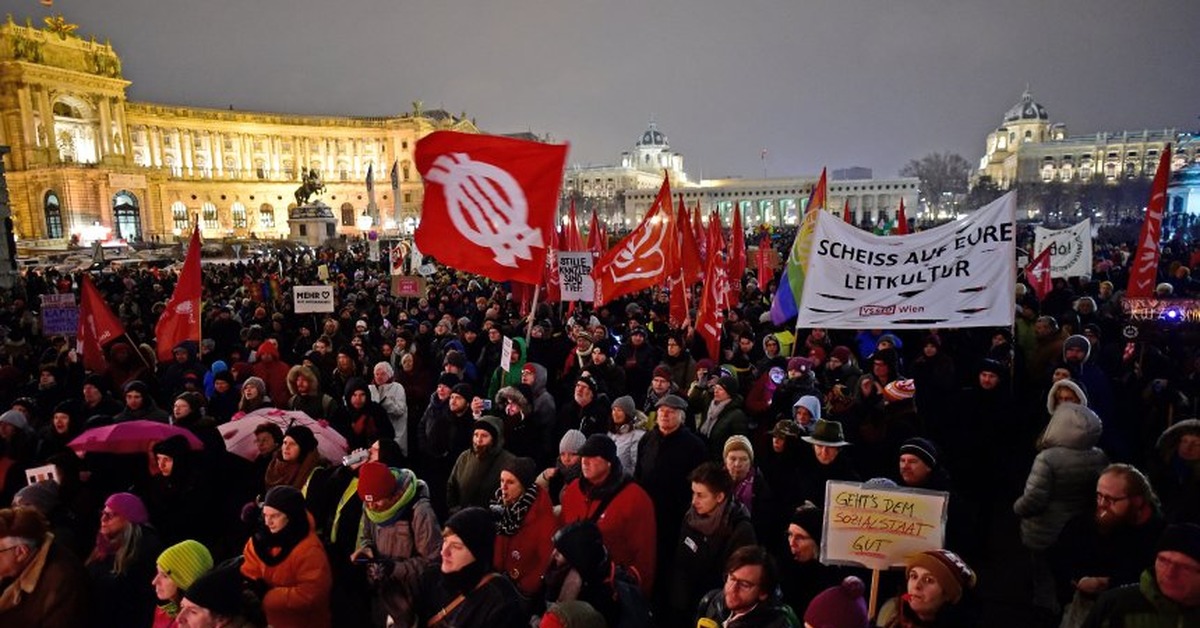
[241,515,334,628]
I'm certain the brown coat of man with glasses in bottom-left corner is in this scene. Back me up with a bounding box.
[0,533,91,628]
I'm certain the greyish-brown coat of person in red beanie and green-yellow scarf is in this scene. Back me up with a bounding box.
[358,482,442,626]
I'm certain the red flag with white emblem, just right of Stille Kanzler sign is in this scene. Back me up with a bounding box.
[592,178,674,307]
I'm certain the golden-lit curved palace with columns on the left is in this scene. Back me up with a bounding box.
[0,16,478,246]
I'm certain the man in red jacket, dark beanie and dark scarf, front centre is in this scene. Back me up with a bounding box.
[559,433,658,596]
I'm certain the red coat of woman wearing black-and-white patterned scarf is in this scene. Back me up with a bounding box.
[492,489,558,597]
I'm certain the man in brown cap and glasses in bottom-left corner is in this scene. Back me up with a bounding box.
[0,508,91,628]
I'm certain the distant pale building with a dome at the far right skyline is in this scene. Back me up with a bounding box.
[974,90,1200,189]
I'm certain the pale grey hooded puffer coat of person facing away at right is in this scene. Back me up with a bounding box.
[1013,402,1109,550]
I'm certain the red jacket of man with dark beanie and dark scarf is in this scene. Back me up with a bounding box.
[559,474,658,597]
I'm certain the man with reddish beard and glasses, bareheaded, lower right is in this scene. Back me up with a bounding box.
[1051,463,1164,626]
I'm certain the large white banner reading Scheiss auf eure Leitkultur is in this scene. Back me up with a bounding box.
[796,192,1016,330]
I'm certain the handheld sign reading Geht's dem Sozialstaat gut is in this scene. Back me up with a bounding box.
[821,480,949,569]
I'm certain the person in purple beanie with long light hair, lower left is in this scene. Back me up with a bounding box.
[85,492,162,628]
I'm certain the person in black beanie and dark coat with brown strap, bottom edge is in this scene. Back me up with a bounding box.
[414,507,528,627]
